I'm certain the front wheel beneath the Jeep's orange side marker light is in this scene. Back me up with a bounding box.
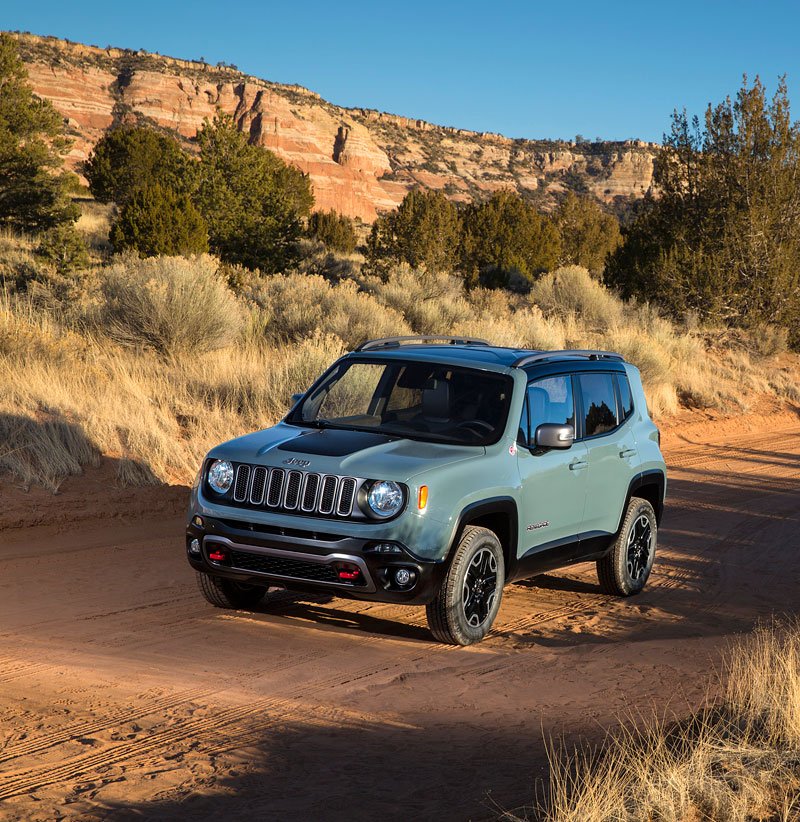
[426,525,505,645]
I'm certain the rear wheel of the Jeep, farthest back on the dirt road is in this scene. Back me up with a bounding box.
[597,497,658,597]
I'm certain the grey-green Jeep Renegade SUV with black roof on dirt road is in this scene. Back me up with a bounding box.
[186,337,666,645]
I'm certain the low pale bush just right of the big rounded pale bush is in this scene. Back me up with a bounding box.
[241,274,411,348]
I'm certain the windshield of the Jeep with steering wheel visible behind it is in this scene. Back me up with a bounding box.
[287,360,513,445]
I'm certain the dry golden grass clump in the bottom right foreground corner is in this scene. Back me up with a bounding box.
[520,622,800,822]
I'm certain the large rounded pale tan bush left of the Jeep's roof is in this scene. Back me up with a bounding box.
[98,255,242,357]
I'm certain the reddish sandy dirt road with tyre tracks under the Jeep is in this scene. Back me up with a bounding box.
[0,412,800,820]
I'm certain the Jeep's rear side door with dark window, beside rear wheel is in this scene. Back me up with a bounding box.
[575,371,638,536]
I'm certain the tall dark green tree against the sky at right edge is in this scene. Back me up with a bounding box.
[605,79,800,345]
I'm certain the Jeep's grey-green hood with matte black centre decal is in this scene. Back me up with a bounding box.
[209,423,485,482]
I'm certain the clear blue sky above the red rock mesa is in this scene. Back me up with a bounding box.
[0,0,800,140]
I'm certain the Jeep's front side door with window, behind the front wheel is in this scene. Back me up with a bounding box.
[518,375,589,564]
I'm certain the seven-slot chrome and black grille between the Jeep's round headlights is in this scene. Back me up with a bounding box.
[233,464,358,517]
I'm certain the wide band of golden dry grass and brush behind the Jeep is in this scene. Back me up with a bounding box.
[0,222,800,489]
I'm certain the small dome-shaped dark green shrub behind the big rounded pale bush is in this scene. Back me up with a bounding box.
[109,184,208,257]
